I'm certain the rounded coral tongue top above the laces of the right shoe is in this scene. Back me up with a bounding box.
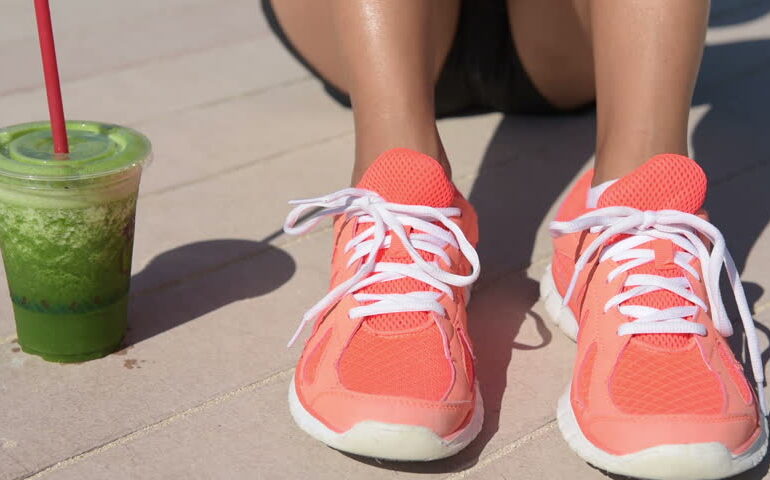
[597,153,706,214]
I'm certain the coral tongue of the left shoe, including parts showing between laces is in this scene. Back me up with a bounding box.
[357,148,455,332]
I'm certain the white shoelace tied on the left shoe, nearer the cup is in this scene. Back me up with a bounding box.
[283,188,480,348]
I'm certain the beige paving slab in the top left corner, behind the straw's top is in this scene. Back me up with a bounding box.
[0,0,267,99]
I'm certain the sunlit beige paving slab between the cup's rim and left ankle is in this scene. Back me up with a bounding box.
[137,80,352,196]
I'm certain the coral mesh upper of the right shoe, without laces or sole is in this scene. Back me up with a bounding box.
[552,155,759,453]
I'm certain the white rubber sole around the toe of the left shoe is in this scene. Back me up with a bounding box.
[289,378,484,461]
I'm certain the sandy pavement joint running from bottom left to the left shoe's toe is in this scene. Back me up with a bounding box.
[21,367,294,480]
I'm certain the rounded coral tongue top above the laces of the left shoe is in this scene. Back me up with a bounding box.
[357,148,455,208]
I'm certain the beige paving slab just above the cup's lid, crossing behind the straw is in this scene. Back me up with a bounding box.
[0,35,307,125]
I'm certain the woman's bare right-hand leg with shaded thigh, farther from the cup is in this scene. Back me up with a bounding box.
[509,0,709,185]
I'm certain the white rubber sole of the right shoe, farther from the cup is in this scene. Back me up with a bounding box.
[540,266,768,480]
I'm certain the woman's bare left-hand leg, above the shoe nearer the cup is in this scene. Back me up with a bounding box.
[273,0,460,184]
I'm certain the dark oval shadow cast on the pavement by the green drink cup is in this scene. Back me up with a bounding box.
[124,237,295,347]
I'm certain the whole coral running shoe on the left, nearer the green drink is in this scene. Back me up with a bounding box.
[284,149,484,460]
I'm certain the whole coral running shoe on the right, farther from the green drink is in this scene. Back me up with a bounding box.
[541,154,767,480]
